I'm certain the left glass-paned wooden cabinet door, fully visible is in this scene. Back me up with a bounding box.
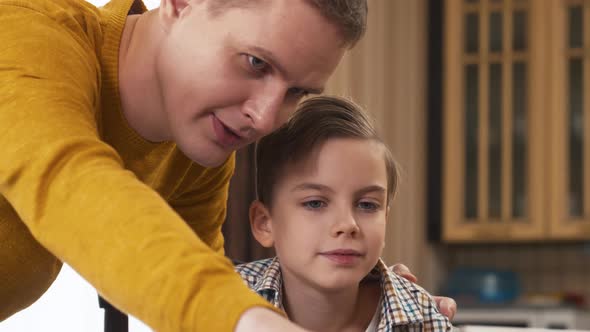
[443,0,543,242]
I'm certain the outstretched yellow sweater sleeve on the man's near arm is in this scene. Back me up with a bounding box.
[0,4,280,331]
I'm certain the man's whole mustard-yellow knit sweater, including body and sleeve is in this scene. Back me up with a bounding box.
[0,0,272,331]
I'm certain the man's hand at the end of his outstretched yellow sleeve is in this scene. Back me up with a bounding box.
[234,307,309,332]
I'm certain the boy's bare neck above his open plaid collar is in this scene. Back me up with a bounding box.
[283,276,381,332]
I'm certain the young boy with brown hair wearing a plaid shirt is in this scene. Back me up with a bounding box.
[236,97,451,332]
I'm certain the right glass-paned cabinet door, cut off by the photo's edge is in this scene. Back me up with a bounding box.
[550,0,590,239]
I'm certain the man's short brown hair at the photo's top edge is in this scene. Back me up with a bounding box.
[209,0,368,48]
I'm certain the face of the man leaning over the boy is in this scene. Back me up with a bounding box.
[156,0,345,166]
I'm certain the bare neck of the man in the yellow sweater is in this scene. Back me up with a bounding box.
[119,10,168,142]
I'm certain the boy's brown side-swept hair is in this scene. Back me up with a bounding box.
[256,96,399,207]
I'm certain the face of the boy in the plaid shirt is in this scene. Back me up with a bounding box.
[258,139,387,290]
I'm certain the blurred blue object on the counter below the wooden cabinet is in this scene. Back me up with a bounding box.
[443,267,521,304]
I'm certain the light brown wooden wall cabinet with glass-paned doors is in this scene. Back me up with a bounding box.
[442,0,590,242]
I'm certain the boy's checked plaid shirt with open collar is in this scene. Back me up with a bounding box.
[236,257,452,332]
